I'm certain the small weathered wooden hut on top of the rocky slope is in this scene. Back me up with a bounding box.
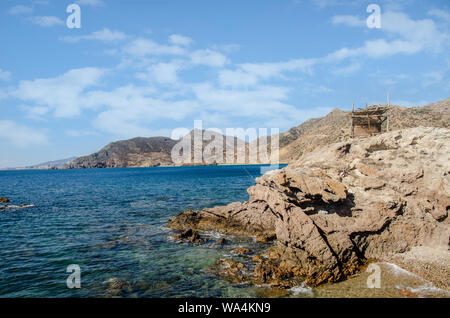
[350,105,389,138]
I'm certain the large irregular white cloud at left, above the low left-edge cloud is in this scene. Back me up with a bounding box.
[11,67,105,118]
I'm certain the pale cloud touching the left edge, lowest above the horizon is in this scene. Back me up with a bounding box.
[0,120,48,147]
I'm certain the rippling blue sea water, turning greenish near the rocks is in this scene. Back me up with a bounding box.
[0,165,286,297]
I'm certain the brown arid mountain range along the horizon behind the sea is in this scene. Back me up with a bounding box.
[12,98,450,169]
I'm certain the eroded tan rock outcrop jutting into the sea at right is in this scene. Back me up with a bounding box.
[169,127,450,286]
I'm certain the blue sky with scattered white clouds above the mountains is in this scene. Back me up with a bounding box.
[0,0,450,168]
